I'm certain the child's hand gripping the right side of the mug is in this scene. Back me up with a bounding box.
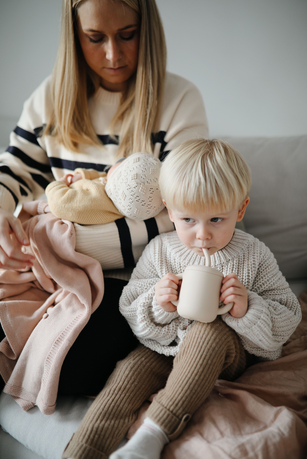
[220,273,248,319]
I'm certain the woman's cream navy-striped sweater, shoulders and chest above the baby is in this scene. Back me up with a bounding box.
[0,72,208,216]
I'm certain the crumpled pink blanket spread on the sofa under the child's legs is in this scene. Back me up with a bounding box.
[129,292,307,459]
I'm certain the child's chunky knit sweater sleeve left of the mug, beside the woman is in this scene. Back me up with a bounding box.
[120,237,181,347]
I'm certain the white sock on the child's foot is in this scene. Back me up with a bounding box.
[109,418,169,459]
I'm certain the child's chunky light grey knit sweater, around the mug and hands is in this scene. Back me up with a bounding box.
[120,230,301,360]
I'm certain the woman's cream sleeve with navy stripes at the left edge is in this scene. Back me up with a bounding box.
[0,79,53,212]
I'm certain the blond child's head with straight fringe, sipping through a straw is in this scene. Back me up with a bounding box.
[159,139,251,255]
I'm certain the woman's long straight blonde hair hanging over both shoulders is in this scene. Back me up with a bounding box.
[45,0,166,157]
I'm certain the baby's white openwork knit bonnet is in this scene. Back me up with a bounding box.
[105,153,164,220]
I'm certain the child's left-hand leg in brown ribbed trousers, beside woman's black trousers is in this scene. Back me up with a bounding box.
[63,345,173,459]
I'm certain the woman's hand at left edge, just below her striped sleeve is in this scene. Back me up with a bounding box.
[0,209,34,269]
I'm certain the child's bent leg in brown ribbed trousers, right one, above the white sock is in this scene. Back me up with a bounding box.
[147,318,246,440]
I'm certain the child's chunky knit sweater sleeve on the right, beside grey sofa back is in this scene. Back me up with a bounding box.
[223,243,302,360]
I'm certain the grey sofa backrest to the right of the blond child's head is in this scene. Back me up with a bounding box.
[224,135,307,280]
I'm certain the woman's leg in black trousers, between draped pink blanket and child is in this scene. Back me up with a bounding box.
[59,278,139,395]
